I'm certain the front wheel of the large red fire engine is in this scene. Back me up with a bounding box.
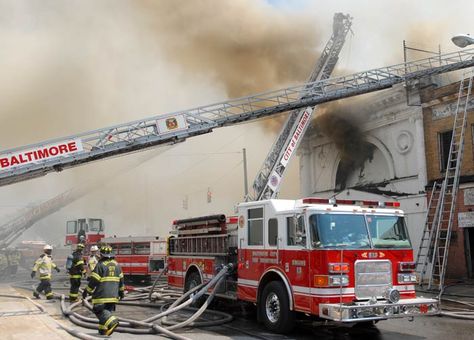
[260,281,295,333]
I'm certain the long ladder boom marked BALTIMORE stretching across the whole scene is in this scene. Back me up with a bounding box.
[0,49,474,186]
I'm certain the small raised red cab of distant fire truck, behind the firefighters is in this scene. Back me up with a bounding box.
[66,218,105,245]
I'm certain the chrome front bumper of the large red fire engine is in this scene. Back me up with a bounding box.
[319,298,439,322]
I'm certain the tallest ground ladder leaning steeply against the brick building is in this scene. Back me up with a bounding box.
[422,71,474,293]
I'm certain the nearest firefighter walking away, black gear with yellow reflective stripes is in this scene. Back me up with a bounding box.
[82,245,125,335]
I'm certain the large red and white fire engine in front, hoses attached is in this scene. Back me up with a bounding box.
[168,198,439,333]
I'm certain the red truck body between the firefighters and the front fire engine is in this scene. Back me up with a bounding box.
[101,236,167,282]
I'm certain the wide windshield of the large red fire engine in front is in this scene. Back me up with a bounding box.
[309,213,410,249]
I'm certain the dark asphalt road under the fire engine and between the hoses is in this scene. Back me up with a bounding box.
[3,275,474,340]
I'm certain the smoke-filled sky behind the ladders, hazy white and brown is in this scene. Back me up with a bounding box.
[0,0,473,243]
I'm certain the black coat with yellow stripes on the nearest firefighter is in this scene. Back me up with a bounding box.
[86,259,125,304]
